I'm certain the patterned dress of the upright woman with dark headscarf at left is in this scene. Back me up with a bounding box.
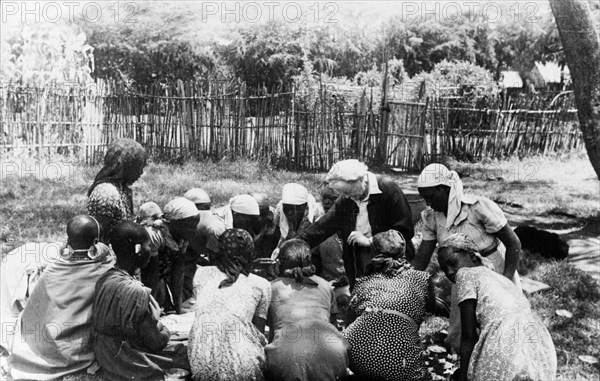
[87,182,133,237]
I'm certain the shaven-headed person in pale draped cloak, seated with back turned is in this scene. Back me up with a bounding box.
[9,215,114,380]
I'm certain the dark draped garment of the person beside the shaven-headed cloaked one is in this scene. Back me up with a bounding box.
[93,268,189,380]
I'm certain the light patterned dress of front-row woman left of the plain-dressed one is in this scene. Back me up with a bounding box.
[188,266,271,381]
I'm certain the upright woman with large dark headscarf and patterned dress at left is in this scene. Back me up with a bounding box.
[87,139,147,242]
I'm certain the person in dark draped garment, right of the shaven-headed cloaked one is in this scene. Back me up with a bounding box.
[92,221,189,380]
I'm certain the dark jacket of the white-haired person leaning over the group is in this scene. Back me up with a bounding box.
[297,176,415,286]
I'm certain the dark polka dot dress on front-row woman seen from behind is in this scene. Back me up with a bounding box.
[344,269,433,381]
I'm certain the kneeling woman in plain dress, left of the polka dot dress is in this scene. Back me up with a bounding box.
[265,239,349,381]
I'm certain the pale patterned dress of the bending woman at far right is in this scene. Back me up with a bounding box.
[456,266,556,381]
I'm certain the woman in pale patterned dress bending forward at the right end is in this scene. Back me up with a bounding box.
[438,233,556,381]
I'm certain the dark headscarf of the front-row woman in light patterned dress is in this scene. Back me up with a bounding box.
[211,229,254,288]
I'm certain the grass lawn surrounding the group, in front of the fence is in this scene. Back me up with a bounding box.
[0,155,600,380]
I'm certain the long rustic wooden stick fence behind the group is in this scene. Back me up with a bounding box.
[0,81,582,170]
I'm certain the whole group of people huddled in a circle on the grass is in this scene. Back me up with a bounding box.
[0,139,556,381]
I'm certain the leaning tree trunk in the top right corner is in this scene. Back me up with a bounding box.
[550,0,600,178]
